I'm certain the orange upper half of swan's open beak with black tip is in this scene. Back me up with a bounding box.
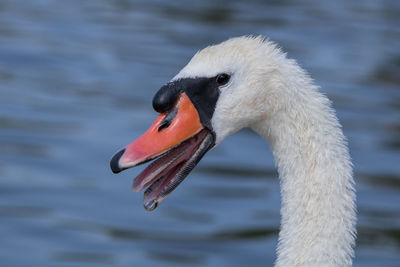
[110,93,203,173]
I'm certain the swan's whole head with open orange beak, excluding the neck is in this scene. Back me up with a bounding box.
[111,37,285,210]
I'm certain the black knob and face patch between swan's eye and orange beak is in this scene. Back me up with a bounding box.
[153,74,223,131]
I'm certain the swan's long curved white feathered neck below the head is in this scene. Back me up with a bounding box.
[252,88,355,267]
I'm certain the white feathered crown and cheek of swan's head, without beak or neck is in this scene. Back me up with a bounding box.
[177,36,287,144]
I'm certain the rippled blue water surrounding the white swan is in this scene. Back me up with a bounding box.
[0,0,400,266]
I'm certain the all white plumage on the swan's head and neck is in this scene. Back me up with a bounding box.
[173,37,356,267]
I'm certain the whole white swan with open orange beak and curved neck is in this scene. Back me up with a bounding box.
[110,36,356,267]
